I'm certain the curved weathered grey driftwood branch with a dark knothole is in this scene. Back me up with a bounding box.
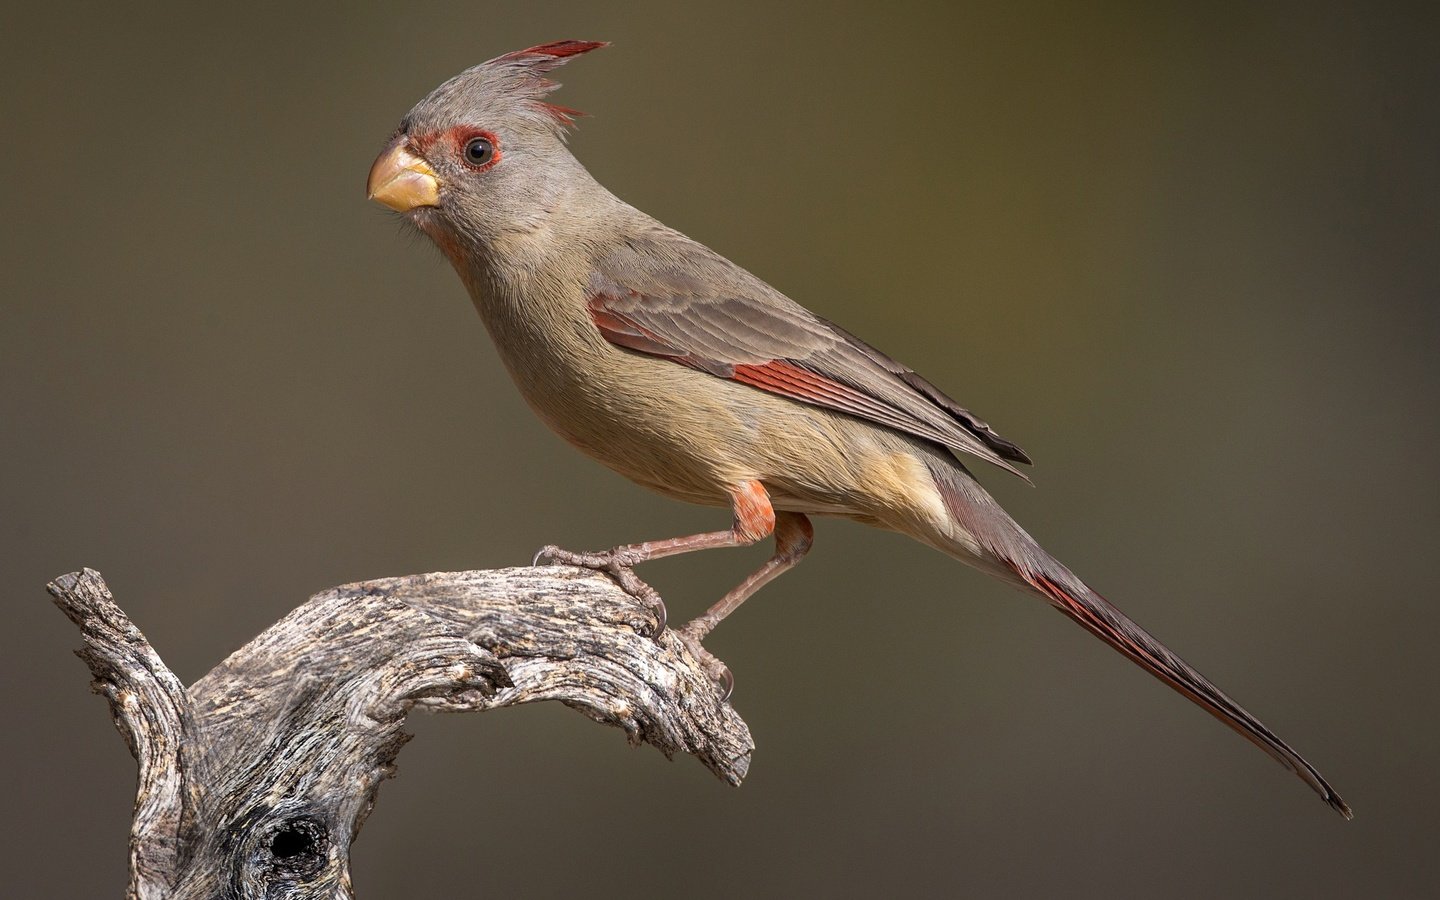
[49,567,753,900]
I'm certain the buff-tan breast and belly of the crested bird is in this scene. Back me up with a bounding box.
[455,270,961,527]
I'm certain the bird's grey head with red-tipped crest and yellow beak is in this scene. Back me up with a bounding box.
[366,40,606,259]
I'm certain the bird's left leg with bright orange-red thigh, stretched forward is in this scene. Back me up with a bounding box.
[531,481,775,639]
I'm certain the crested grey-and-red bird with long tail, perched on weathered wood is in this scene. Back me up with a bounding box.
[366,40,1351,818]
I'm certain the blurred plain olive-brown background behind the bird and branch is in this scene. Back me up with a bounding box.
[0,0,1440,899]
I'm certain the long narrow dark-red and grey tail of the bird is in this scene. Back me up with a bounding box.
[930,462,1354,819]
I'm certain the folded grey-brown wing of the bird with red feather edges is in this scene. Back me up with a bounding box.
[588,232,1030,478]
